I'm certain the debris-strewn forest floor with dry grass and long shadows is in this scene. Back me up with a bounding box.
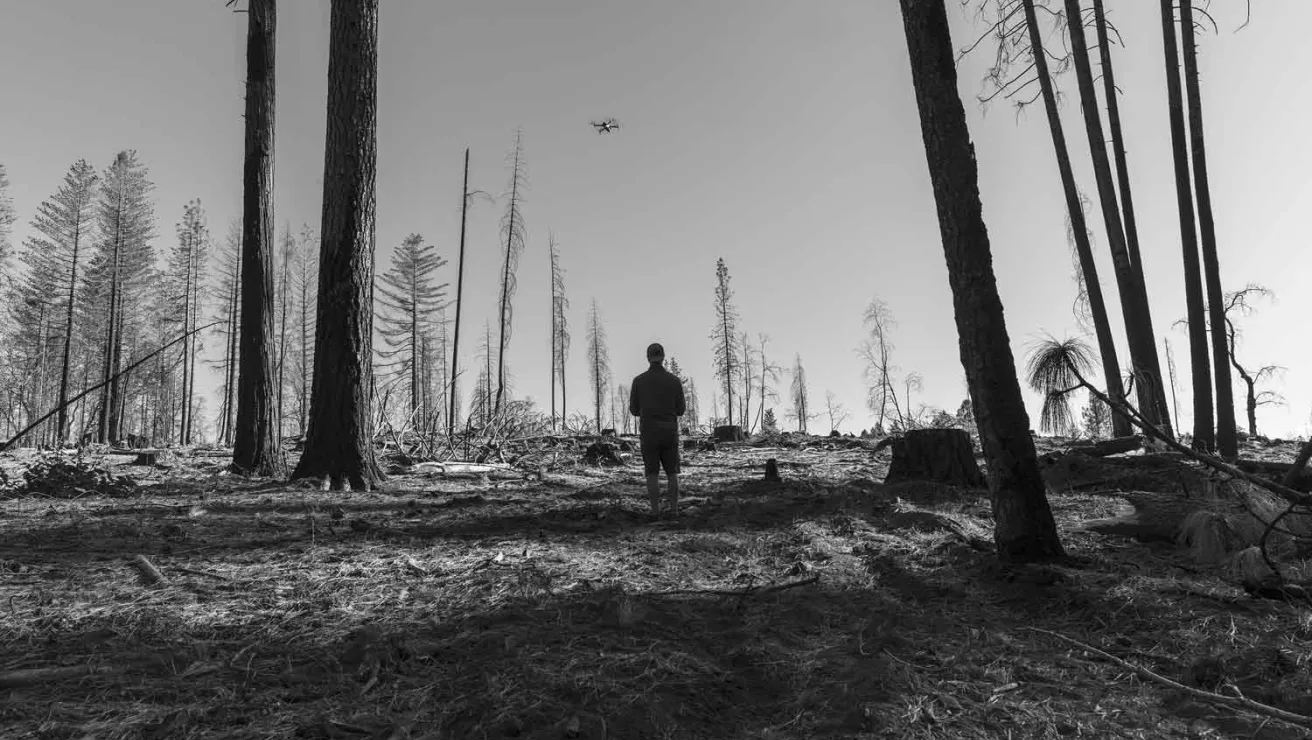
[0,438,1312,740]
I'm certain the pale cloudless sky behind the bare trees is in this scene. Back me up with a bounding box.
[0,0,1312,437]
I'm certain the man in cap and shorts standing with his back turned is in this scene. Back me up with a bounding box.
[628,344,685,516]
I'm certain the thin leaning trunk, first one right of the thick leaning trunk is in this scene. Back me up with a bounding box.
[1022,0,1134,437]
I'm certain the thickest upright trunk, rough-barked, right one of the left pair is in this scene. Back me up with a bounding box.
[293,0,383,491]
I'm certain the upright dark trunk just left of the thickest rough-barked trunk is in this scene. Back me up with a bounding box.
[232,0,283,476]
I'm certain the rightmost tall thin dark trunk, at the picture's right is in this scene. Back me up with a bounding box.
[1179,0,1239,461]
